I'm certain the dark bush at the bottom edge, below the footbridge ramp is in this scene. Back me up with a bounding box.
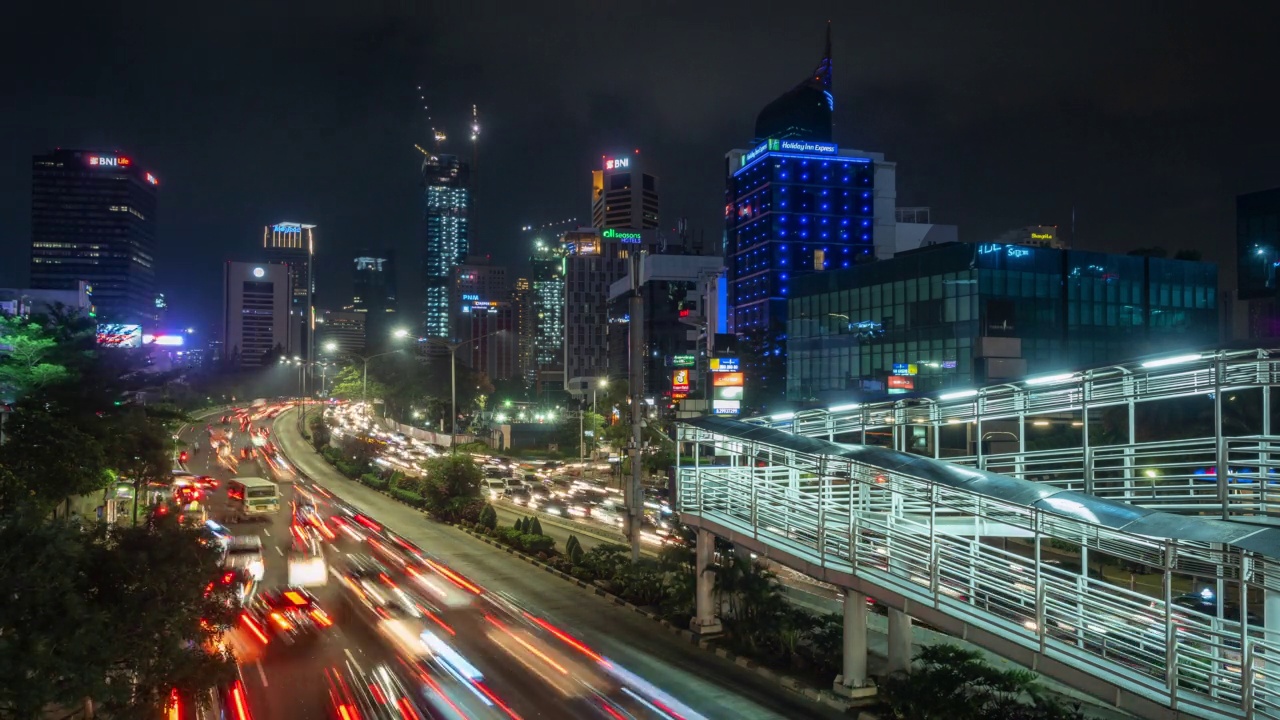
[879,644,1084,720]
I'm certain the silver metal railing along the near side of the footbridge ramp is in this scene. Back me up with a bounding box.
[677,425,1280,720]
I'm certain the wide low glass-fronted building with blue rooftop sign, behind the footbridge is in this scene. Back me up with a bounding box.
[787,243,1219,401]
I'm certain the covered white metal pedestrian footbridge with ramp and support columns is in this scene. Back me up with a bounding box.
[676,354,1280,720]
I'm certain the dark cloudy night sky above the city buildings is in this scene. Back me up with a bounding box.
[0,0,1280,328]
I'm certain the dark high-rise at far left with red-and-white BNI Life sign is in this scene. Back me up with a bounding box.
[31,150,160,325]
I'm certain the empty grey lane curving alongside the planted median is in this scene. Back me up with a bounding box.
[259,411,846,719]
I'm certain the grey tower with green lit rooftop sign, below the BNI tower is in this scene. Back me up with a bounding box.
[561,228,662,392]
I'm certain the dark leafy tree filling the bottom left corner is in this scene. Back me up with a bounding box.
[0,519,237,717]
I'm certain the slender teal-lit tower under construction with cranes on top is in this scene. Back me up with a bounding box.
[422,155,471,338]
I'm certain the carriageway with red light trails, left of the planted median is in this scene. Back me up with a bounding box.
[182,411,842,720]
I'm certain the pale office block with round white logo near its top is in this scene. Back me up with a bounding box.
[223,261,296,368]
